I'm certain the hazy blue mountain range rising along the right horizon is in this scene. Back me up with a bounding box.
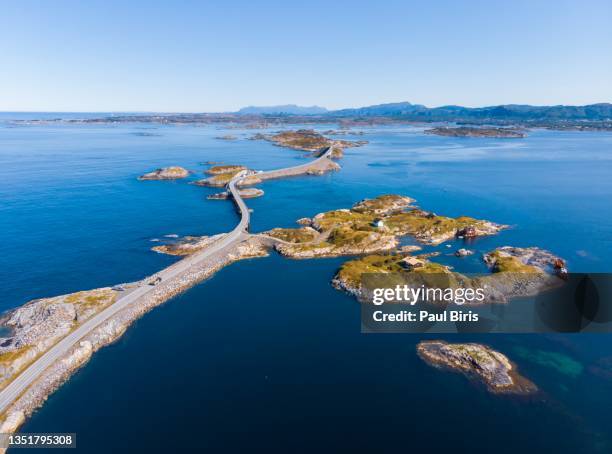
[238,102,612,121]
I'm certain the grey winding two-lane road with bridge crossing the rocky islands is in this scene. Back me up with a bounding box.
[0,145,334,414]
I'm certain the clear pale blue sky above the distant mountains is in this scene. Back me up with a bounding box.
[0,0,612,112]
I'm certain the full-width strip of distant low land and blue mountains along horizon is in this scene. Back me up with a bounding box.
[0,102,612,131]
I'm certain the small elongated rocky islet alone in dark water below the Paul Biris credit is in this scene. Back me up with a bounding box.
[417,340,537,394]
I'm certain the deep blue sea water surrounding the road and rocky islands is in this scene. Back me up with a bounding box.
[0,122,612,453]
